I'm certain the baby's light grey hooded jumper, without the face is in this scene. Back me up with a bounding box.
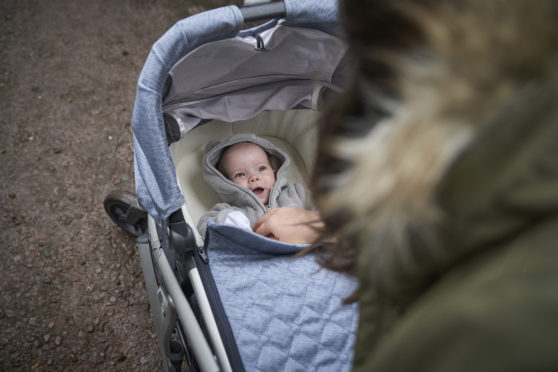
[198,133,310,236]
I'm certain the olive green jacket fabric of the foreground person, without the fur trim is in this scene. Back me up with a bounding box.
[354,76,558,372]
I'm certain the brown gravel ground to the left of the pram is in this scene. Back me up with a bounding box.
[0,0,232,371]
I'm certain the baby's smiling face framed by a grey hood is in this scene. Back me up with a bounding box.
[221,142,275,204]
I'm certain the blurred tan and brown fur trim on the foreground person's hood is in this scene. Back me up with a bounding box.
[316,0,558,303]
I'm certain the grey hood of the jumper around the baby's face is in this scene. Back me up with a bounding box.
[202,133,290,208]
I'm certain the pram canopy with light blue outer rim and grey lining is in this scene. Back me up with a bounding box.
[132,0,343,224]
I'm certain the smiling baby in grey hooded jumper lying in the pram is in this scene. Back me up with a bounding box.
[198,133,310,236]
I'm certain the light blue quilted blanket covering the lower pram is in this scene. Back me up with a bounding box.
[206,224,358,372]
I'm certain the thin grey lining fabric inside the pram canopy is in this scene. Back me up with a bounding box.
[163,22,345,137]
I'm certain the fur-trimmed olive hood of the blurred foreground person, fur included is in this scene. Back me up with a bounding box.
[315,0,558,307]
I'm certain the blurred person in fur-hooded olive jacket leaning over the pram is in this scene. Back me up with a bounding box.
[313,0,558,372]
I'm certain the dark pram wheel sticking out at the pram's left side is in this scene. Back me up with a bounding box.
[103,190,147,236]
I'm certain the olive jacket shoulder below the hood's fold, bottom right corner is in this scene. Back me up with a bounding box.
[366,222,558,372]
